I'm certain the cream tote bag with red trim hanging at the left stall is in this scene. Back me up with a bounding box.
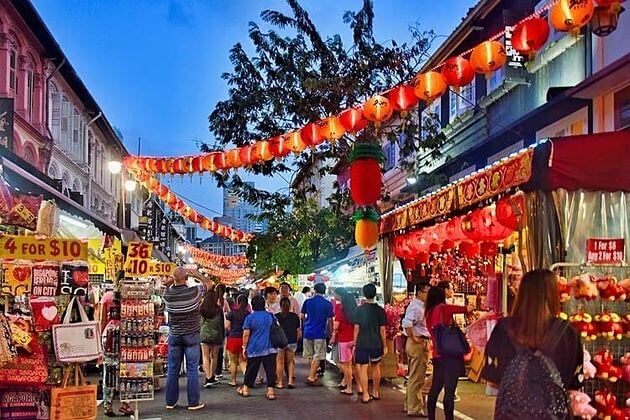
[52,297,101,362]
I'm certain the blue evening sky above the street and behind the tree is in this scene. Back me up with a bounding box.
[32,0,476,221]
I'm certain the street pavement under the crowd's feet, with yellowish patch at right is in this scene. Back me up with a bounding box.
[97,357,492,420]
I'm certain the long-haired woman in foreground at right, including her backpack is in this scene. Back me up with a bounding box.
[481,270,584,419]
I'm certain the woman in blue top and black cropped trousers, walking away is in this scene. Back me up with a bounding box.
[237,296,278,400]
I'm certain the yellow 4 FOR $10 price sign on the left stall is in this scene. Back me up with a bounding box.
[0,235,88,261]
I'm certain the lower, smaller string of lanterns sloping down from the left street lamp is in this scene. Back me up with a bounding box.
[131,170,253,243]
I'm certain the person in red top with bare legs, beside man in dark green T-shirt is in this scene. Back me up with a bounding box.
[330,287,357,395]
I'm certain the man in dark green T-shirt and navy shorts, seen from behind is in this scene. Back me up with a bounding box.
[352,283,387,404]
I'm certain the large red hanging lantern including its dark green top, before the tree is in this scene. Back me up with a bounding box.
[350,143,383,206]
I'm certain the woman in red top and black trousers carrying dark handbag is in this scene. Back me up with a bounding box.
[426,287,474,420]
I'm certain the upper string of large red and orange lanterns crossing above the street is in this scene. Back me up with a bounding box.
[124,0,612,175]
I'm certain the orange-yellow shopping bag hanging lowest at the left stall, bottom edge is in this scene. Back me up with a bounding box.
[50,363,97,420]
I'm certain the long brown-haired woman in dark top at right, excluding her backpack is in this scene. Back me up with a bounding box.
[481,270,584,418]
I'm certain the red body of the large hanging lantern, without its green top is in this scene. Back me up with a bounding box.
[350,159,383,206]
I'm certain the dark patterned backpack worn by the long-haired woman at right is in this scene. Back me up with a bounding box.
[494,321,571,420]
